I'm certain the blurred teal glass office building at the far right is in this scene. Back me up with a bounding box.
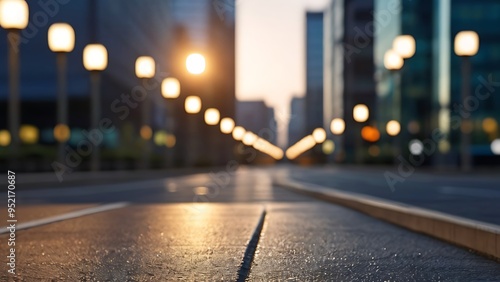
[375,0,500,166]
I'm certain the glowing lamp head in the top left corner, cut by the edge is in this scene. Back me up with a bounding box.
[0,0,29,30]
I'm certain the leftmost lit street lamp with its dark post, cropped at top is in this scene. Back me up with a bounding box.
[0,0,29,167]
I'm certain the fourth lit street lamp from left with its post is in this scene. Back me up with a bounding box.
[135,56,155,169]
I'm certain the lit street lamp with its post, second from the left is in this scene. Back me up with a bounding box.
[48,23,75,162]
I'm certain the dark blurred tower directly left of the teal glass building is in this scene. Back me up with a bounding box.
[323,0,377,162]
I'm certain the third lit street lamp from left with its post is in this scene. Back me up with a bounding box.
[83,44,108,171]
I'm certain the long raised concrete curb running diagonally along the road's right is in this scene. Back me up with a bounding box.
[273,178,500,261]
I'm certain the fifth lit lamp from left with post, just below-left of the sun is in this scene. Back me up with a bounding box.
[161,77,181,167]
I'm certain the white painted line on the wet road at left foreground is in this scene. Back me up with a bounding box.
[0,202,129,234]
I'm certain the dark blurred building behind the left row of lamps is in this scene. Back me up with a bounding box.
[0,0,235,170]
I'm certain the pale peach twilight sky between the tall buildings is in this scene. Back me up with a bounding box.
[236,0,329,146]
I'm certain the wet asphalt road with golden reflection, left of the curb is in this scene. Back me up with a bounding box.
[0,167,500,281]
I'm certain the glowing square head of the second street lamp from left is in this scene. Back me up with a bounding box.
[48,23,75,53]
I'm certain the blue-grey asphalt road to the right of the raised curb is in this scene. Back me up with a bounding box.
[283,167,500,225]
